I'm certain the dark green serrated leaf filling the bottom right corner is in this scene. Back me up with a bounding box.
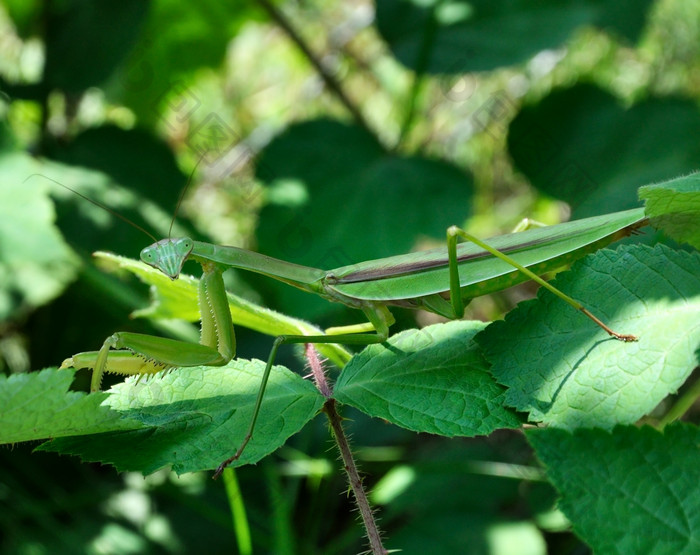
[527,424,700,555]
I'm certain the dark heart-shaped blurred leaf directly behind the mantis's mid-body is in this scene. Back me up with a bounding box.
[257,120,472,317]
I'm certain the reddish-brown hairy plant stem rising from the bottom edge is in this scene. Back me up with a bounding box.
[306,344,388,555]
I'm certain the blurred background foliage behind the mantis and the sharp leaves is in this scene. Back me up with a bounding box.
[0,0,700,554]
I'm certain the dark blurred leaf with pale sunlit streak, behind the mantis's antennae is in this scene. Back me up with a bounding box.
[28,139,186,257]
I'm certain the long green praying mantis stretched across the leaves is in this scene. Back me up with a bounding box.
[59,178,647,477]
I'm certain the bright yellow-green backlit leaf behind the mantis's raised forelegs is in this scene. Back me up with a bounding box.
[95,252,350,372]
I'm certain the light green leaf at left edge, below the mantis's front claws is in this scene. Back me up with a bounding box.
[0,368,142,443]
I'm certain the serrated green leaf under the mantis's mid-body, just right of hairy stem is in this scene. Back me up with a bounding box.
[333,321,520,437]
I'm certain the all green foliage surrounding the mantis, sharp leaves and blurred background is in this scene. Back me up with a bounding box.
[0,0,700,555]
